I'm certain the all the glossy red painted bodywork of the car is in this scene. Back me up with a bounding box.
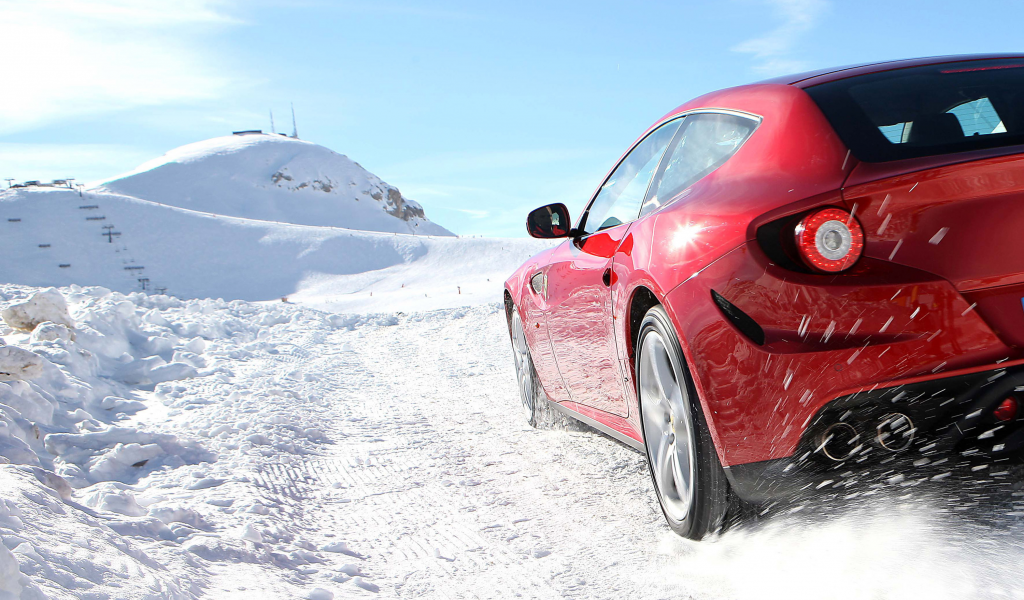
[506,55,1024,485]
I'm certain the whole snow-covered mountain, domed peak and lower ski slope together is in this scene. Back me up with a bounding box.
[0,134,548,303]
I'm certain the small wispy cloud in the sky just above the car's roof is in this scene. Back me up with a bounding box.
[732,0,827,75]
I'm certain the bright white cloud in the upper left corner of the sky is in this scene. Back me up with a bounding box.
[0,0,237,134]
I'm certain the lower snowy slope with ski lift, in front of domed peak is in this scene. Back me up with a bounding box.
[0,189,548,301]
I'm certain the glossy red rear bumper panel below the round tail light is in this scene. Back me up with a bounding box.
[666,243,1011,466]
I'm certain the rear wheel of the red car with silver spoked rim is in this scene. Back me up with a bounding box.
[636,306,729,540]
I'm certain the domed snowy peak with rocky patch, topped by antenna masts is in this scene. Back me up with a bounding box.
[98,134,452,235]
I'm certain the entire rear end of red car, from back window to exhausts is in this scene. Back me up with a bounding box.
[686,57,1024,497]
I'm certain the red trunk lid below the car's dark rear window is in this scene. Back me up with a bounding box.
[843,149,1024,346]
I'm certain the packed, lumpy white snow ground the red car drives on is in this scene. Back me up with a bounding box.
[0,285,1024,599]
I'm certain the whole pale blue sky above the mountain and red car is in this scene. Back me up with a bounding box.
[0,0,1024,237]
